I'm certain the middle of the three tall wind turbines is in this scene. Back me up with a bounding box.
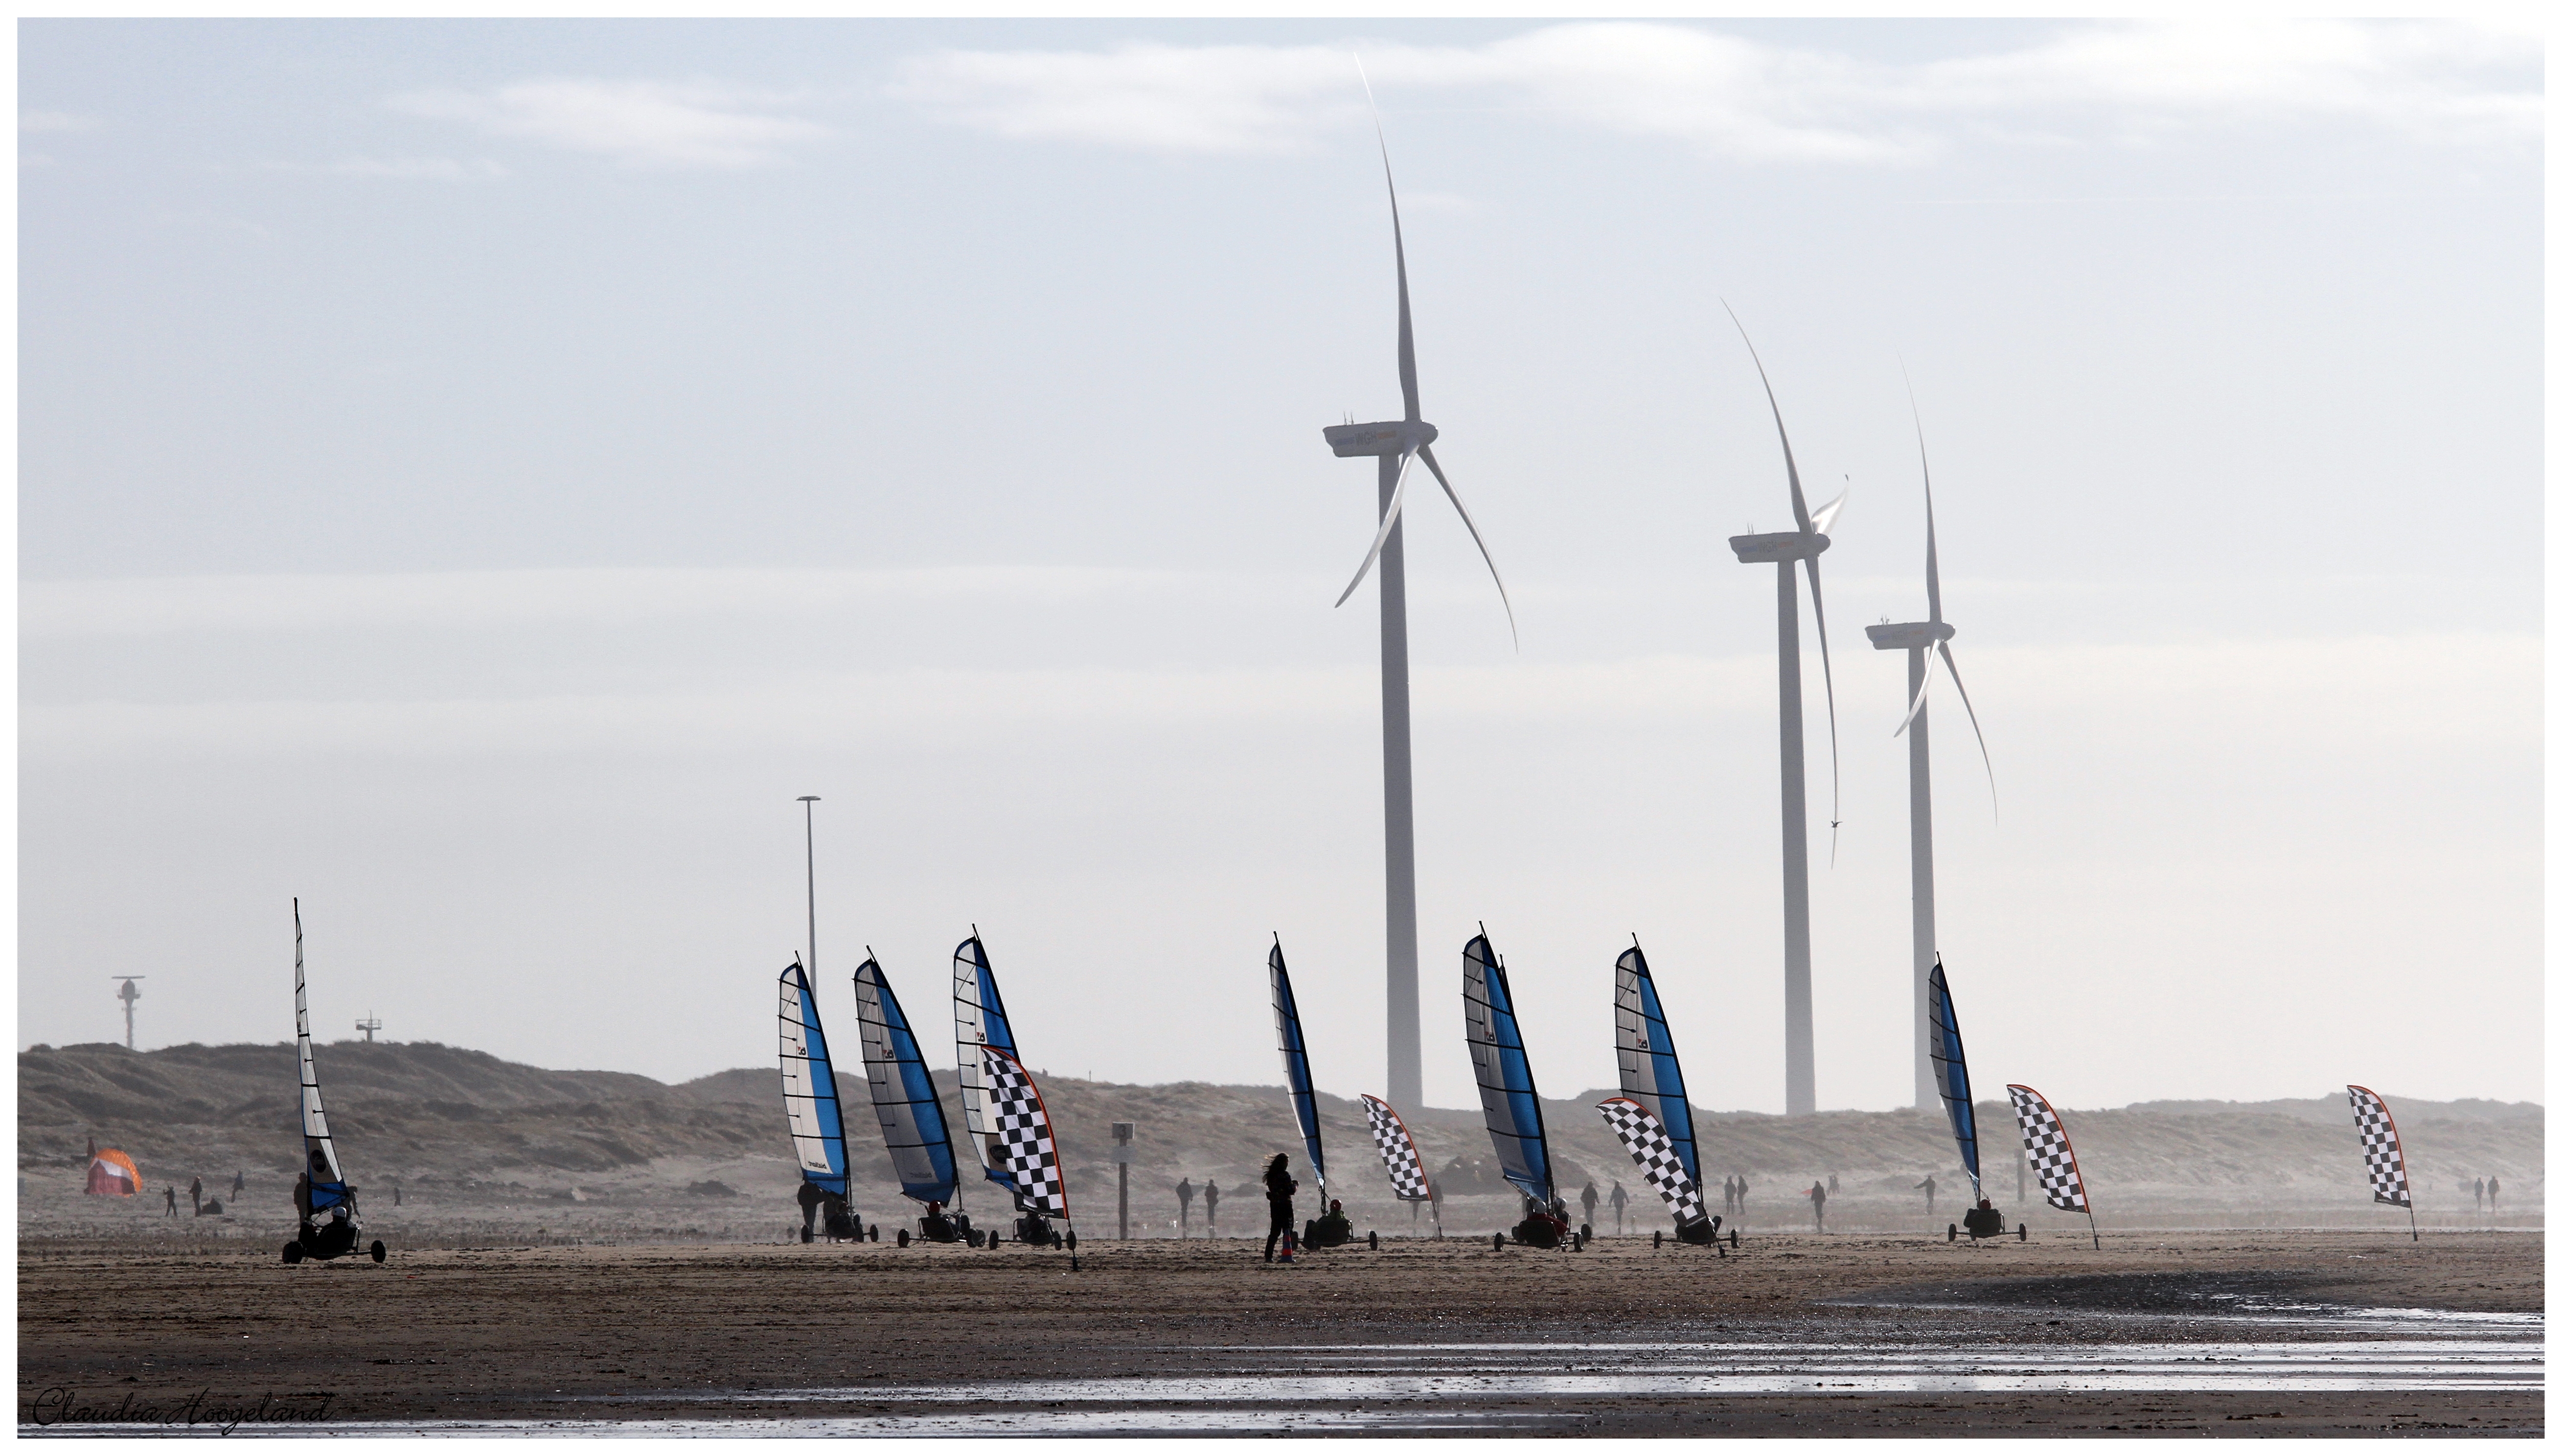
[1727,308,1850,1118]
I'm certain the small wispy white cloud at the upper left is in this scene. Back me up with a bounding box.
[387,77,828,167]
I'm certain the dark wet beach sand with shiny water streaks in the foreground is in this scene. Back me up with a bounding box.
[18,1233,2544,1436]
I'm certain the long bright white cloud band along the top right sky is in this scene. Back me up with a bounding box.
[889,20,2544,164]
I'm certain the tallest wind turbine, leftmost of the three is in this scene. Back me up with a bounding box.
[1324,77,1522,1107]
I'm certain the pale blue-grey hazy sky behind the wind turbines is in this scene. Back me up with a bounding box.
[18,20,2544,1110]
